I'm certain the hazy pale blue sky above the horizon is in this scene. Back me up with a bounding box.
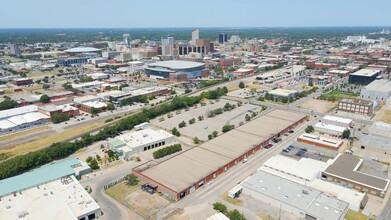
[0,0,391,28]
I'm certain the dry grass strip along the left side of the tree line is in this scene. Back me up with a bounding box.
[0,121,105,157]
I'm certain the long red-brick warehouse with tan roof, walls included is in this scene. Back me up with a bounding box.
[133,110,307,200]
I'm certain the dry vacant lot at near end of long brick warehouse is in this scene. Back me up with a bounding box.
[106,182,170,219]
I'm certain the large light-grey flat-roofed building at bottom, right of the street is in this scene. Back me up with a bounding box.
[241,171,349,220]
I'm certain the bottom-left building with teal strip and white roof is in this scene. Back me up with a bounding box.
[0,159,101,220]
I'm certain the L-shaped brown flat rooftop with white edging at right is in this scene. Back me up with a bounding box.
[324,154,390,191]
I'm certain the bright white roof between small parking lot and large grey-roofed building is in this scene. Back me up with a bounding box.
[262,155,328,181]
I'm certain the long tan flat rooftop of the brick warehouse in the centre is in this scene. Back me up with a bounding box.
[142,110,305,192]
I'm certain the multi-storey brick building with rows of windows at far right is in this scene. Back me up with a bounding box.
[338,99,373,115]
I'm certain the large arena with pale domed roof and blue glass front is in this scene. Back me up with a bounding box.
[145,60,209,81]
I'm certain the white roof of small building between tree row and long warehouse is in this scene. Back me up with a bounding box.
[117,128,173,149]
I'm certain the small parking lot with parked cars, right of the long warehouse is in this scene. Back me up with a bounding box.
[281,142,338,162]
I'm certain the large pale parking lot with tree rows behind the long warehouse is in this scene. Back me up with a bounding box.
[151,100,262,140]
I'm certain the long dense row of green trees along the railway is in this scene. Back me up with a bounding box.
[0,88,230,179]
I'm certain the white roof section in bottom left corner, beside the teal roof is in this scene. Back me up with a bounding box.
[0,176,100,220]
